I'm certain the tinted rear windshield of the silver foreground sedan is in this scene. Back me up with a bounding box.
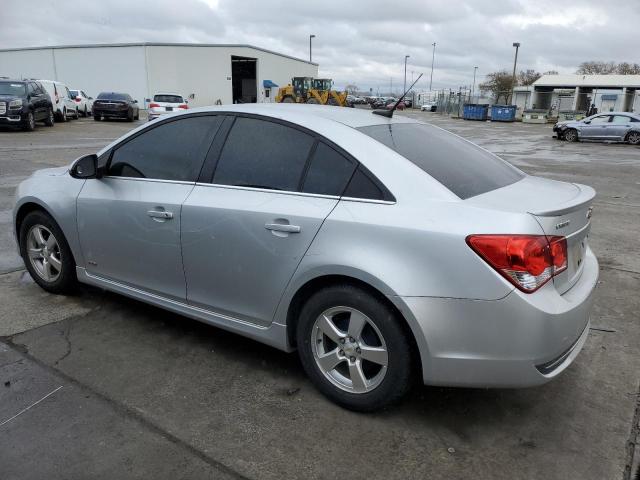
[358,123,524,200]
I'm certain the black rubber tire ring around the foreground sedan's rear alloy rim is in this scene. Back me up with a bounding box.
[296,284,415,412]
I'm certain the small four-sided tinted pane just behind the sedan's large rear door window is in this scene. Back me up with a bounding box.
[302,142,356,196]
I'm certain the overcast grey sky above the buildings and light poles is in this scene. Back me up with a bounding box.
[0,0,640,93]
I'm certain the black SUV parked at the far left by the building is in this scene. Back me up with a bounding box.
[0,78,53,131]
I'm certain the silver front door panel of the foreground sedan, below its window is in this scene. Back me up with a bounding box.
[77,177,194,300]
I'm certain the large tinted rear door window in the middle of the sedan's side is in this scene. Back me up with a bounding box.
[213,117,315,192]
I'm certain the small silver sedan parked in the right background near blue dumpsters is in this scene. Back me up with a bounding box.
[553,112,640,145]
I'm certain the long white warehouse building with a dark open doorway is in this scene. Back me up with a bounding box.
[0,43,318,107]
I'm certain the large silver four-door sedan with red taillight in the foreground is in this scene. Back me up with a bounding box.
[14,104,598,411]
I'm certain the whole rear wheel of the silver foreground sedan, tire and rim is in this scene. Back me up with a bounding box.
[296,285,413,412]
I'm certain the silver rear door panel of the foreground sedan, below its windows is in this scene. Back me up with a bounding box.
[182,184,338,325]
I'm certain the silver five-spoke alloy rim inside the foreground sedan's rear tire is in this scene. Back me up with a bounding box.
[311,307,389,393]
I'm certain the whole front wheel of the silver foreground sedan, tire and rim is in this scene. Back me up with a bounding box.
[20,211,76,293]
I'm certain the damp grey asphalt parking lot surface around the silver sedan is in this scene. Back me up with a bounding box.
[0,112,640,480]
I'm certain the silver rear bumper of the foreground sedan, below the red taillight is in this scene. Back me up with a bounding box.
[390,249,598,387]
